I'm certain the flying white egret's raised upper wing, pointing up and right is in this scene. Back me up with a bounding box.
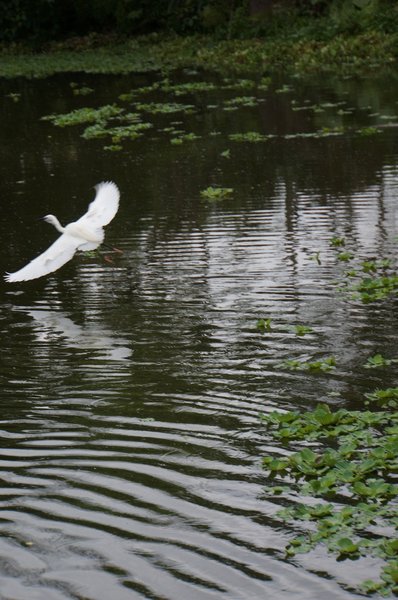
[76,181,120,229]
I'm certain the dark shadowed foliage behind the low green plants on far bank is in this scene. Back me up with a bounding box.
[0,0,398,44]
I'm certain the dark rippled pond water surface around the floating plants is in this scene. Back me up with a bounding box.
[0,74,398,600]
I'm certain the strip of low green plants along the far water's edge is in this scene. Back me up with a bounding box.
[0,31,398,77]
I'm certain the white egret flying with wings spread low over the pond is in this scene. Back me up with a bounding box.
[4,181,121,282]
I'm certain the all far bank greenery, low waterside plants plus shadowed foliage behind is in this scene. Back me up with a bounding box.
[0,0,398,77]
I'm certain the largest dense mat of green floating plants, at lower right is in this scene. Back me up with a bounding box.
[262,398,398,596]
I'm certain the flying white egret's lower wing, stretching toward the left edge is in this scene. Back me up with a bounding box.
[4,233,81,283]
